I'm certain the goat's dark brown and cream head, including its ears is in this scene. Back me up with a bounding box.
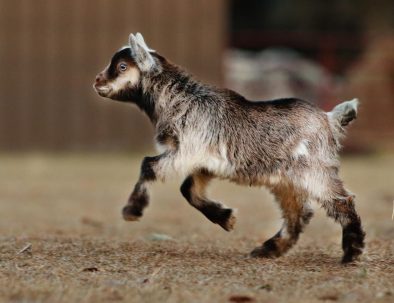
[93,33,161,101]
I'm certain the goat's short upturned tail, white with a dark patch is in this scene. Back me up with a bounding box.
[327,99,359,145]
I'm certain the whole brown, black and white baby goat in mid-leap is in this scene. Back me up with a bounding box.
[94,33,365,263]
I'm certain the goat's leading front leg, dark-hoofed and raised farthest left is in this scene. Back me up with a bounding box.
[122,154,169,221]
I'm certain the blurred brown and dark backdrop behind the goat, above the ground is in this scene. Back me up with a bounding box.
[0,0,394,152]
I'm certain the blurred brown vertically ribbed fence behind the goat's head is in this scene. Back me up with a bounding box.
[0,0,226,150]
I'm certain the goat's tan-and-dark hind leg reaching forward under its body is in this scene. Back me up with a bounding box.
[251,187,313,258]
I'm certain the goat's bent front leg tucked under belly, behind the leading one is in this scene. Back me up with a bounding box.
[181,172,236,231]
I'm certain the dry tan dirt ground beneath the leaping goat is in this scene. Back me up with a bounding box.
[0,154,394,303]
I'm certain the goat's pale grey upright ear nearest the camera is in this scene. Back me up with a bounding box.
[129,33,156,72]
